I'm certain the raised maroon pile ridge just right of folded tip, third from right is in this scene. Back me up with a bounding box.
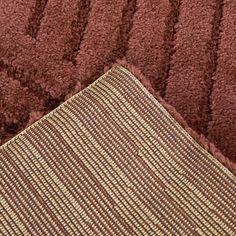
[127,0,173,93]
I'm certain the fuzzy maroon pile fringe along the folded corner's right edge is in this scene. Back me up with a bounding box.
[104,58,236,175]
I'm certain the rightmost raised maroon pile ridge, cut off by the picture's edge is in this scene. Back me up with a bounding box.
[208,1,236,160]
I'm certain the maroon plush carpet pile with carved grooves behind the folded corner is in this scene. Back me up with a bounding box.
[0,0,236,161]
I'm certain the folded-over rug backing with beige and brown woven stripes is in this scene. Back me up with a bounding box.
[0,66,236,235]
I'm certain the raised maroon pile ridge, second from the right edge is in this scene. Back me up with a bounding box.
[165,1,221,135]
